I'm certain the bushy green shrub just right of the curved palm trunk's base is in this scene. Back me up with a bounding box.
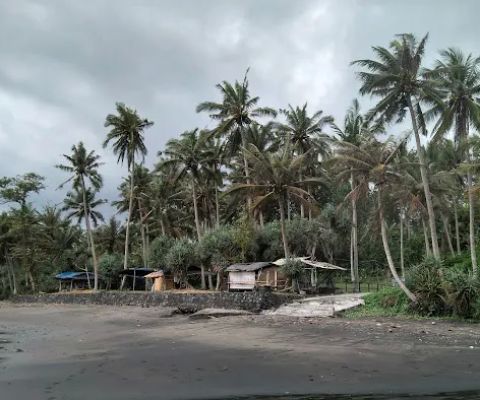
[406,258,446,316]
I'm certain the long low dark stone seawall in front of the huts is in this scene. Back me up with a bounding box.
[9,291,297,313]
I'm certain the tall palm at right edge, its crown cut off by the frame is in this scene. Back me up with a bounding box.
[427,48,480,274]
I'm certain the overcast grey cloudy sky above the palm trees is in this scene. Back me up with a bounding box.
[0,0,480,216]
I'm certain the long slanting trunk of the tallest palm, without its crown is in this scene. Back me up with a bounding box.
[407,97,440,260]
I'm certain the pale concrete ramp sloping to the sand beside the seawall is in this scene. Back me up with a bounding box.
[263,293,365,317]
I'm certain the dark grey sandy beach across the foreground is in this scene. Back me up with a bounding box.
[0,303,480,400]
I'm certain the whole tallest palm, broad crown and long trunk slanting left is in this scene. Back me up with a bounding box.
[352,34,440,259]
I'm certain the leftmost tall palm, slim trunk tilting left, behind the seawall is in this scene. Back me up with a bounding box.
[56,142,102,290]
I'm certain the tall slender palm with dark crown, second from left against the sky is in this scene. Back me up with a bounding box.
[103,103,153,269]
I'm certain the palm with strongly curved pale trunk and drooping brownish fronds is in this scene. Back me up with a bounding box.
[335,139,416,301]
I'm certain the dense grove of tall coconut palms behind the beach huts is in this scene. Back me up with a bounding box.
[0,34,480,301]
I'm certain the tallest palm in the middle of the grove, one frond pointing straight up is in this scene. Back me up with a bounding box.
[197,70,277,207]
